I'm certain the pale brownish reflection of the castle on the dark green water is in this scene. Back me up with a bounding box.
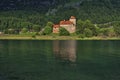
[53,41,76,62]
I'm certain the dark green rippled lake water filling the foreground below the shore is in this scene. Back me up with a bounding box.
[0,41,120,80]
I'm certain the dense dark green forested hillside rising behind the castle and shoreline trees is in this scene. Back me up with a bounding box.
[0,0,120,36]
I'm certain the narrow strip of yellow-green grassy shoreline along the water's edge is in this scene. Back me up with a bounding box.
[0,35,120,40]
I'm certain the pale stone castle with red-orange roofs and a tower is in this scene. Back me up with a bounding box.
[53,16,76,33]
